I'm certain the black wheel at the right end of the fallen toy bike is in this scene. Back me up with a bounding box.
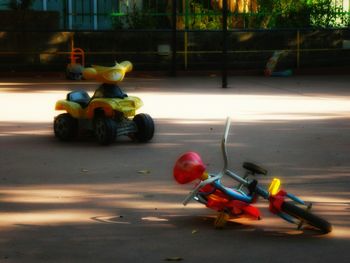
[281,202,332,233]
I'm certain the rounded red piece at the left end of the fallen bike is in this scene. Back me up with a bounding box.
[173,152,205,184]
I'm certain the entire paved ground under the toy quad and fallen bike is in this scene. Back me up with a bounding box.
[0,76,350,262]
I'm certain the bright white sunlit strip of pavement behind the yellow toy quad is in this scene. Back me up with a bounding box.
[0,90,350,122]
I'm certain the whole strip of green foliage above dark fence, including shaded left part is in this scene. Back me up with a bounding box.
[110,0,350,30]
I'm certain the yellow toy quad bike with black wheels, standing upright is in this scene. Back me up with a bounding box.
[53,61,154,145]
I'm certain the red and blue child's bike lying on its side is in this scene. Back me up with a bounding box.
[173,118,332,233]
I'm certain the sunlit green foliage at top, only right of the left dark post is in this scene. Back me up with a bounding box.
[180,0,350,30]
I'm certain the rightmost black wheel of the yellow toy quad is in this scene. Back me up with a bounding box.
[133,113,154,142]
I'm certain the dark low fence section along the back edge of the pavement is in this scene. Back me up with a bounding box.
[0,29,350,72]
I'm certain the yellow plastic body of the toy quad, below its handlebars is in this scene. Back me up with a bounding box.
[55,96,143,119]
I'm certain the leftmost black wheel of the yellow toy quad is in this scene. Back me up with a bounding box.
[53,113,78,141]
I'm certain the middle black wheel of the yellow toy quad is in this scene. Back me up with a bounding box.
[94,117,117,145]
